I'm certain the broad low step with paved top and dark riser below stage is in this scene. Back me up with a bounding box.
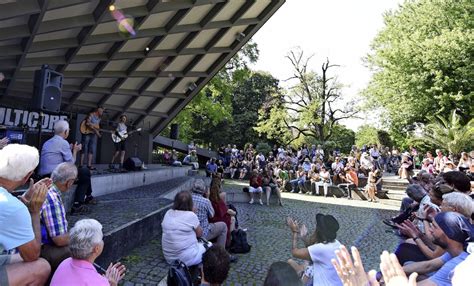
[68,176,193,268]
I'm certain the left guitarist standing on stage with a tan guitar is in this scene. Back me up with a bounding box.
[81,106,104,170]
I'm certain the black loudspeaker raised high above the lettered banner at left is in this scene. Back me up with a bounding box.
[33,65,63,112]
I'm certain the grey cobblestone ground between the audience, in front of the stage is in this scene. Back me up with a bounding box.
[118,181,398,285]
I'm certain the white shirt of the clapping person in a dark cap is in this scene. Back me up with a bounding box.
[308,240,342,286]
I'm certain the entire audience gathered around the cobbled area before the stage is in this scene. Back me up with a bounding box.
[0,123,474,285]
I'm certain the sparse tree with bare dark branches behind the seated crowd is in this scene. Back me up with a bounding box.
[256,50,358,144]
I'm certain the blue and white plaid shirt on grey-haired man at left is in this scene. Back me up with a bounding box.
[40,184,67,244]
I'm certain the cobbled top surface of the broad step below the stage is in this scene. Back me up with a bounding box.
[68,177,188,233]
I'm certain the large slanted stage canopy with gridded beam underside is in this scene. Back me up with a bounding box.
[0,0,285,134]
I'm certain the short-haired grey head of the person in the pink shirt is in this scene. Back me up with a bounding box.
[69,219,104,260]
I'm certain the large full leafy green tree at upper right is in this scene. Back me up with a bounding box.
[364,0,474,137]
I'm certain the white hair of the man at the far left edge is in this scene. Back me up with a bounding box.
[0,144,39,182]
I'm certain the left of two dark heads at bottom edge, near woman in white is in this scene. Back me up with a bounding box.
[201,245,230,286]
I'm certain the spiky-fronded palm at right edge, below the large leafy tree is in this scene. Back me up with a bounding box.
[415,111,474,156]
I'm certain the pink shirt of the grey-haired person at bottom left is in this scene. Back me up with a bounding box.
[50,258,110,286]
